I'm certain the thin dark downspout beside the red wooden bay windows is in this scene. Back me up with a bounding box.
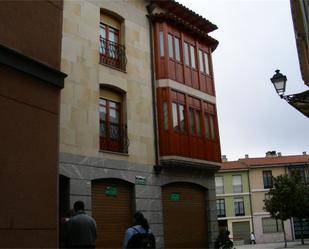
[147,4,161,173]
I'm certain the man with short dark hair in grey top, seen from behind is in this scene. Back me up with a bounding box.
[66,201,97,248]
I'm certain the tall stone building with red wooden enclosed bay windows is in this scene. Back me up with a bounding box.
[60,0,221,248]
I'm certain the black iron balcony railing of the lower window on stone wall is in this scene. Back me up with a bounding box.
[100,123,130,153]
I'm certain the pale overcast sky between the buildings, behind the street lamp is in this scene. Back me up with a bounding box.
[178,0,309,160]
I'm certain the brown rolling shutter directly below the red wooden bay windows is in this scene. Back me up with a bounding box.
[162,183,208,248]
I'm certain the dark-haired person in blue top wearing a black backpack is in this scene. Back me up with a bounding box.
[123,212,156,249]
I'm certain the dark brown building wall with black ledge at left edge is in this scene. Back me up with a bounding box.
[0,0,65,248]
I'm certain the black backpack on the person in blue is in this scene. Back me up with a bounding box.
[127,227,156,249]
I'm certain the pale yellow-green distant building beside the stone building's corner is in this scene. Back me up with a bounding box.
[215,162,253,244]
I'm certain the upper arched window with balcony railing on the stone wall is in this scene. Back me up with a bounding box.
[99,13,126,70]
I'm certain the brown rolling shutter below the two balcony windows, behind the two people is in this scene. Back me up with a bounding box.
[92,179,133,248]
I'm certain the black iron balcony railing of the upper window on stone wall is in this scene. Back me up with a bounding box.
[100,37,127,71]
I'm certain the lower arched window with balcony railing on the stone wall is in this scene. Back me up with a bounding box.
[99,89,129,153]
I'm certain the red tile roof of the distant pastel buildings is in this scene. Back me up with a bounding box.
[220,155,309,170]
